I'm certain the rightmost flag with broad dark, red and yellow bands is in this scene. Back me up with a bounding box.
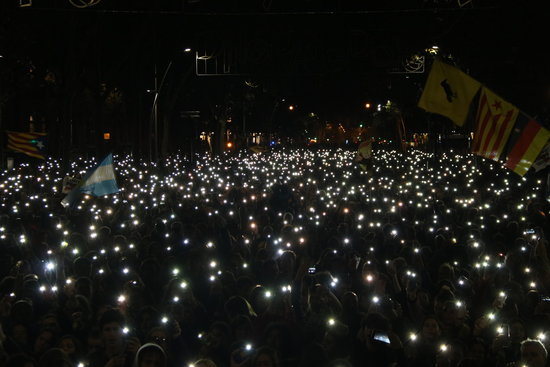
[502,113,550,176]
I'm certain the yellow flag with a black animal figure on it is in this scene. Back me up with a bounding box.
[418,60,481,126]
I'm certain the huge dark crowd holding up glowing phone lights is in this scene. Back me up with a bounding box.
[0,149,550,367]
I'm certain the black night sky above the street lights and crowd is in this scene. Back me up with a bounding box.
[0,0,550,140]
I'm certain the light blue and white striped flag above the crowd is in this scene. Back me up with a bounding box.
[61,154,119,207]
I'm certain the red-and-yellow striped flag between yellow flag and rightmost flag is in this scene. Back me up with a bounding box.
[472,87,520,161]
